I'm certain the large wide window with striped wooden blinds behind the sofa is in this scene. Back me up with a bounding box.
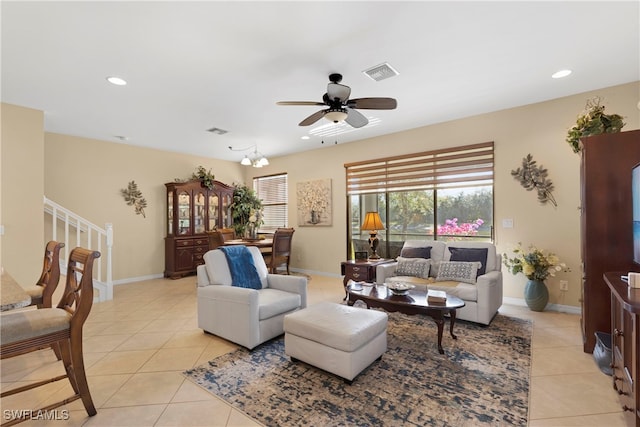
[345,142,493,258]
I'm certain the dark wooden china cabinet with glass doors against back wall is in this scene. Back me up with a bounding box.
[164,180,233,279]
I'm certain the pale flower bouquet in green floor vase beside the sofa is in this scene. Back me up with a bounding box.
[503,243,567,311]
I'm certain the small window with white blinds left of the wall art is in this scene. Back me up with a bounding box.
[253,173,289,232]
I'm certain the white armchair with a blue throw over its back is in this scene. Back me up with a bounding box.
[197,247,307,350]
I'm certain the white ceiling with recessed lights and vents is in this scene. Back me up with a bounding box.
[1,0,640,160]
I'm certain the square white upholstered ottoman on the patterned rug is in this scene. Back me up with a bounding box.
[284,302,388,383]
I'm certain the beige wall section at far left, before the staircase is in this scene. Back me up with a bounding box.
[0,104,44,285]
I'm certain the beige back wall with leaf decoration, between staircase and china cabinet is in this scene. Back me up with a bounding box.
[44,133,242,283]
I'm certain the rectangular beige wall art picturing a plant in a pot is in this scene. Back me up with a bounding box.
[296,179,332,227]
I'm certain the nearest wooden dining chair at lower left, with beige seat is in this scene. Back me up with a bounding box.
[0,247,100,426]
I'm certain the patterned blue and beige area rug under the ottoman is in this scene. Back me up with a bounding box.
[184,313,532,426]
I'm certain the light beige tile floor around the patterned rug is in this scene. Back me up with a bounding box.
[0,276,625,427]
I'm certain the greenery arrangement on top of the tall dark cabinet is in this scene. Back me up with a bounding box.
[567,98,625,153]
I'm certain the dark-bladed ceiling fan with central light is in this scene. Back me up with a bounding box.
[276,73,398,128]
